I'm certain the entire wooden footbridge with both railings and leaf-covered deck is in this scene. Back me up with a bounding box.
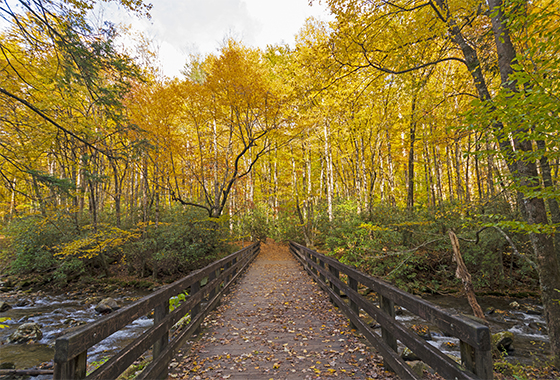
[54,242,493,380]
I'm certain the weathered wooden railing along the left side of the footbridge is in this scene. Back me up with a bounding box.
[53,243,260,380]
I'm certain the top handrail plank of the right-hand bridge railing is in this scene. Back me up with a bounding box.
[294,243,491,351]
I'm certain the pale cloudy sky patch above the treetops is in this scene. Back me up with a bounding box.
[94,0,331,77]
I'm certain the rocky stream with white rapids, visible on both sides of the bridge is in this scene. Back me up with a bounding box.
[0,291,549,378]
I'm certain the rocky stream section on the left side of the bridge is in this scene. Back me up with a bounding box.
[0,291,153,369]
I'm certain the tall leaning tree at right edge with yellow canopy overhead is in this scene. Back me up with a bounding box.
[316,0,560,366]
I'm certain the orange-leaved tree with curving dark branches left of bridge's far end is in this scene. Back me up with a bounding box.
[171,41,286,218]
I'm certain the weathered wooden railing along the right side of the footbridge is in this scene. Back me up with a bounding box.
[290,242,493,380]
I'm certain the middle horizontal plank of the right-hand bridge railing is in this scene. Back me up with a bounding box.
[308,252,478,380]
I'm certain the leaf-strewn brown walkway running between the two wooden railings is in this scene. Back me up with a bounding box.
[169,243,394,379]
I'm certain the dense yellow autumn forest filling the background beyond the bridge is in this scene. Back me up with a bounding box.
[0,0,560,372]
